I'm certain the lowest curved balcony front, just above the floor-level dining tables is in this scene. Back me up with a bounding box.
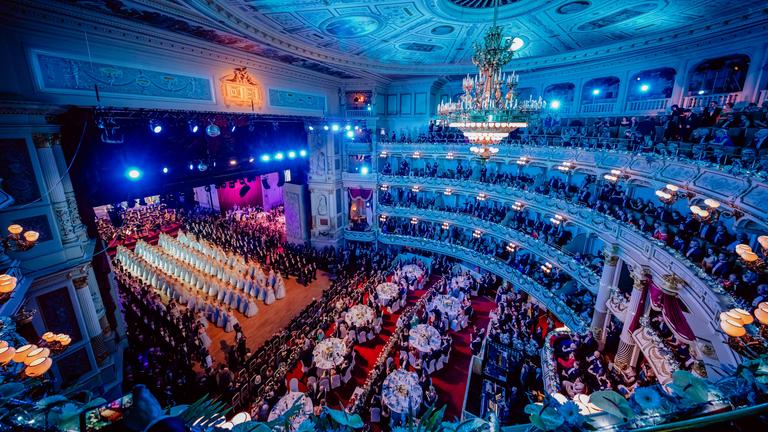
[378,232,587,333]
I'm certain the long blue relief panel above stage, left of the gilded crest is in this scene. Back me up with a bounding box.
[31,51,215,103]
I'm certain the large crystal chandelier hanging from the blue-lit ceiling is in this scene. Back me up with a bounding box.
[437,1,546,159]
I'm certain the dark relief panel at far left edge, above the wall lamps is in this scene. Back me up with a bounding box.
[0,138,40,204]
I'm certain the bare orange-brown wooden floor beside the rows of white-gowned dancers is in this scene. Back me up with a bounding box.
[207,270,330,367]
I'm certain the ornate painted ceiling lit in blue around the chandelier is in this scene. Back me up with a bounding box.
[55,0,765,78]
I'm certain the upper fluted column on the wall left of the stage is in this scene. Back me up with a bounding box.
[32,134,78,244]
